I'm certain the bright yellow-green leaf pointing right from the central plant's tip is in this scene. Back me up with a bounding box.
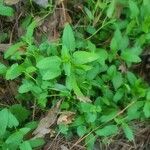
[73,51,99,64]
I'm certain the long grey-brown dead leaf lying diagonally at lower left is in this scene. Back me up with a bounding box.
[33,101,61,138]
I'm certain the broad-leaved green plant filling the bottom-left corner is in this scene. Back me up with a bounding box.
[0,104,44,150]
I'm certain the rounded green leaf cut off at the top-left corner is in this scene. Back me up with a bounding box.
[0,4,14,17]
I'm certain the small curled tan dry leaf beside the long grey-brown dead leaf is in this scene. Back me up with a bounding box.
[57,111,75,124]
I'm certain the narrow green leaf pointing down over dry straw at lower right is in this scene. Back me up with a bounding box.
[122,123,134,141]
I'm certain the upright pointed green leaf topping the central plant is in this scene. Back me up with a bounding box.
[62,23,75,51]
